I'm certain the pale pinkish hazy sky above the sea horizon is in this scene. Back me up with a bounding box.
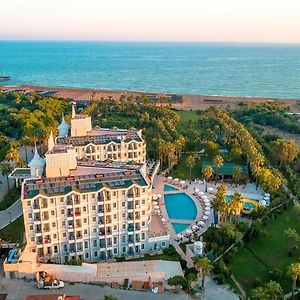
[0,0,300,43]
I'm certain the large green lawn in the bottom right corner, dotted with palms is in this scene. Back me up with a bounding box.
[229,208,300,293]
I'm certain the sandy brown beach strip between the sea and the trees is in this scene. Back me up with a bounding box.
[0,85,300,113]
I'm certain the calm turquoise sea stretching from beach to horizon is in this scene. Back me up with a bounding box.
[0,41,300,99]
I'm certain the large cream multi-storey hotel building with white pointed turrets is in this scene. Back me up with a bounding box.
[21,107,169,263]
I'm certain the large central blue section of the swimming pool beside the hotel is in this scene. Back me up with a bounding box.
[164,193,197,220]
